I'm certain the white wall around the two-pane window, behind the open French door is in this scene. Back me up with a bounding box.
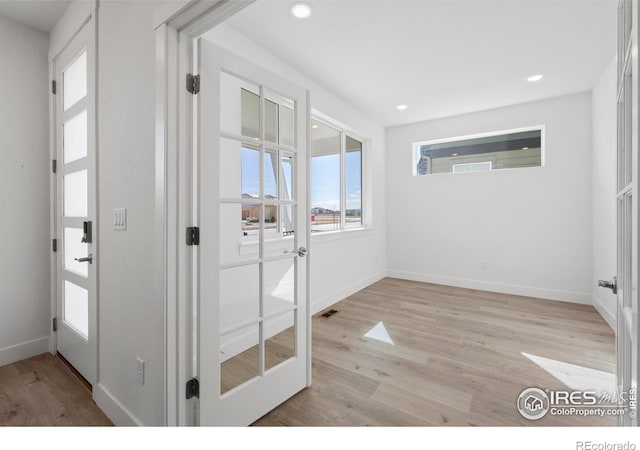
[206,24,386,313]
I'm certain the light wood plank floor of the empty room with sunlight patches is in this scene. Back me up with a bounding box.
[255,278,616,426]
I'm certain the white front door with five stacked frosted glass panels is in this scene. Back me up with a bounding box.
[54,22,96,384]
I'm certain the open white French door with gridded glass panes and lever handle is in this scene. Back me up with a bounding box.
[197,39,310,425]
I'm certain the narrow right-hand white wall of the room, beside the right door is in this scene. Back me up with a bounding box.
[591,59,617,329]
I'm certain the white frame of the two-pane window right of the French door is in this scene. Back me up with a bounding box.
[309,110,364,237]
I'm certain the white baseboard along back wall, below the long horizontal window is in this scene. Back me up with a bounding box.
[388,270,592,305]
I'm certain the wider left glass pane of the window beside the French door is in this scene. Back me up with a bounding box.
[311,120,340,232]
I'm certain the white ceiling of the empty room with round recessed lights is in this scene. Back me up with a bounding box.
[228,0,617,126]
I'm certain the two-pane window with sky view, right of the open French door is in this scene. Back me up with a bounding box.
[311,120,363,233]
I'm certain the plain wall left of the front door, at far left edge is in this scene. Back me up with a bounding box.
[0,17,51,365]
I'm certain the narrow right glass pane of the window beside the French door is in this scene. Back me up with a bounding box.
[345,136,362,228]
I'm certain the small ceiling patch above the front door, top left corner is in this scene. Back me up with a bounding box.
[0,0,71,33]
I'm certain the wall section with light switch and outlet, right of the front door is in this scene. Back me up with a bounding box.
[96,2,165,425]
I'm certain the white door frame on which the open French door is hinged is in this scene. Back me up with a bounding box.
[154,0,311,426]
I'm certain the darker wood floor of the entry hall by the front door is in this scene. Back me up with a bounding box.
[0,353,112,426]
